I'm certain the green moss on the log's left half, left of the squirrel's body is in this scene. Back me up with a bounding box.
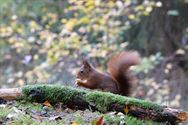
[19,84,85,103]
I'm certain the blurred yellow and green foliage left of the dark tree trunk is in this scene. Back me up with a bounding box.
[0,0,159,86]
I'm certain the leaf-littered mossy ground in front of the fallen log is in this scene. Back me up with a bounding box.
[0,100,159,125]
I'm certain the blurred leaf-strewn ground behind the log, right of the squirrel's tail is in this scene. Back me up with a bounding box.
[133,52,188,110]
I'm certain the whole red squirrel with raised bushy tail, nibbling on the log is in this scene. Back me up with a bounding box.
[76,51,140,96]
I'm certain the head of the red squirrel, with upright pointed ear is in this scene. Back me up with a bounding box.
[76,60,93,80]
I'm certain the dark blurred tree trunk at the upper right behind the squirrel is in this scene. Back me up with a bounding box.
[125,0,188,55]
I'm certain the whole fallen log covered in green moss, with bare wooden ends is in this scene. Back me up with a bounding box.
[0,85,188,125]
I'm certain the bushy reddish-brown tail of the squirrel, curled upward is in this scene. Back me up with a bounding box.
[108,51,140,96]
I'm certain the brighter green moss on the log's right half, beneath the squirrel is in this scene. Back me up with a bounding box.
[86,91,162,111]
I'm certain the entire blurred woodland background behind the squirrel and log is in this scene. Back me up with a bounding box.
[0,0,188,110]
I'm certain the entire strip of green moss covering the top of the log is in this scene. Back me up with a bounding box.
[20,84,162,112]
